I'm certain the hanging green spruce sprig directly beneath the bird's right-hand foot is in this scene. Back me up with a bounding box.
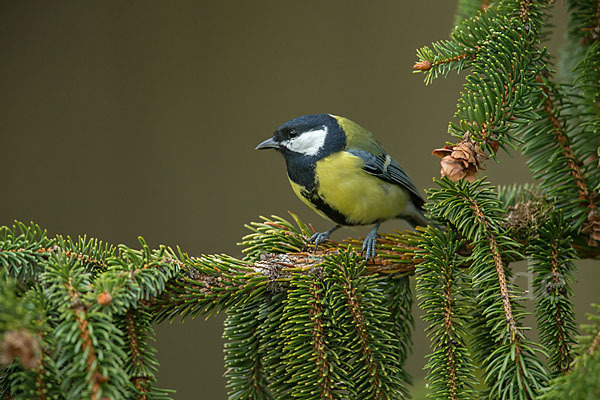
[323,248,406,399]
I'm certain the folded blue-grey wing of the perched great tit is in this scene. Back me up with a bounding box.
[347,149,425,210]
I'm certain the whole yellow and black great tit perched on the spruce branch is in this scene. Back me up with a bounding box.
[256,114,427,261]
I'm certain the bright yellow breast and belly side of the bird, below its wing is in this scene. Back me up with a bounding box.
[312,152,408,225]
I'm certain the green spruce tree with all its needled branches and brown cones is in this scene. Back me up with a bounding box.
[0,0,600,400]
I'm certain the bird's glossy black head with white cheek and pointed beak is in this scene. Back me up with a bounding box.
[256,114,346,161]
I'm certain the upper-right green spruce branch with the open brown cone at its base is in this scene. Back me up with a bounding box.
[418,7,539,180]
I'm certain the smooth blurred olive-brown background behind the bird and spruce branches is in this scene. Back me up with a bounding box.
[0,0,597,399]
